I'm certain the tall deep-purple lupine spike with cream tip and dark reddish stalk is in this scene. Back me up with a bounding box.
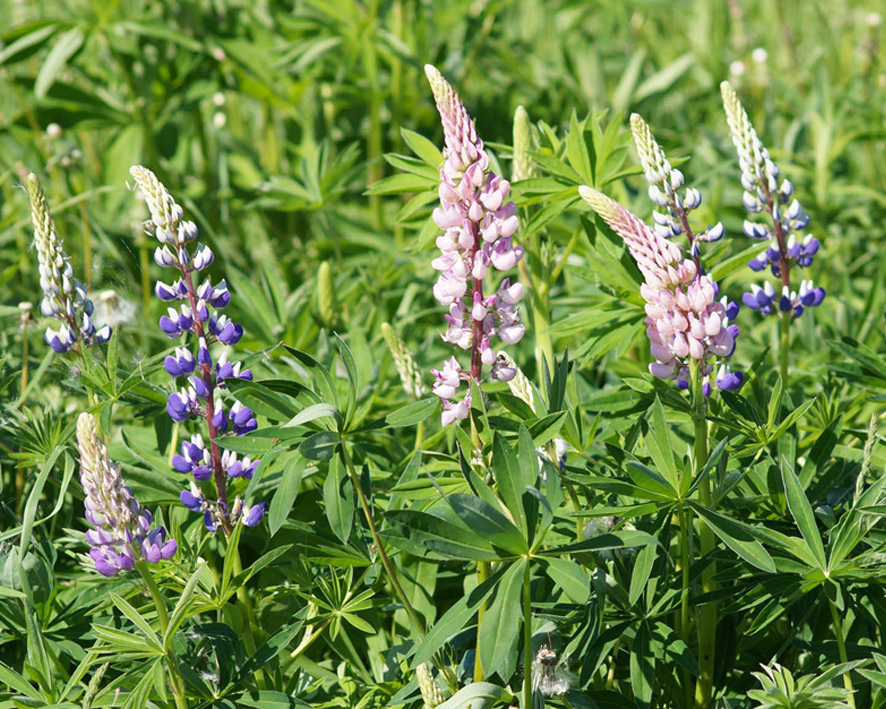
[130,166,267,533]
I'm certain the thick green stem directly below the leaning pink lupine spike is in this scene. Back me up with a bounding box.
[692,361,717,709]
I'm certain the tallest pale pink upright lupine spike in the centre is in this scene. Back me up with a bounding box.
[425,65,524,426]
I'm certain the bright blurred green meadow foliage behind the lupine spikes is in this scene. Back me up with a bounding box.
[0,0,886,705]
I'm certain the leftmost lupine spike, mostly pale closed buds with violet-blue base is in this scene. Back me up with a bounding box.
[28,173,111,354]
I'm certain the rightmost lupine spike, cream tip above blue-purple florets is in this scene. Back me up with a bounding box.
[720,81,825,317]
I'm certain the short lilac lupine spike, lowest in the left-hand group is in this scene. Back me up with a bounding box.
[77,413,178,576]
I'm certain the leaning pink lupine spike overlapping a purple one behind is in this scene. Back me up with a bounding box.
[579,187,743,395]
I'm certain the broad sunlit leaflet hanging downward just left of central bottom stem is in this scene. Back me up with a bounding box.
[477,559,526,677]
